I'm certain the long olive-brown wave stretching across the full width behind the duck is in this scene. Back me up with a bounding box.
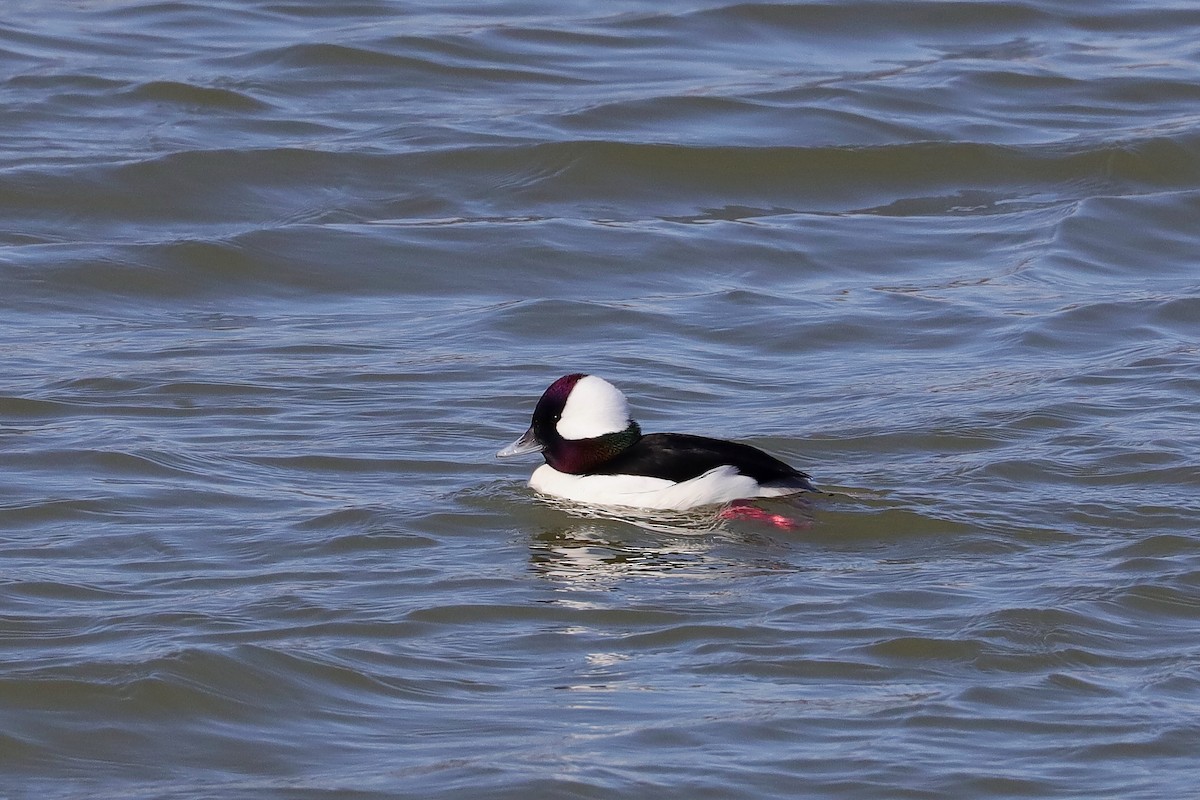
[0,131,1200,230]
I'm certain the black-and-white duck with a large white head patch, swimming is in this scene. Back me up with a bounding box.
[496,373,816,511]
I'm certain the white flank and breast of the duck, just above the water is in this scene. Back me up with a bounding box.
[529,464,763,511]
